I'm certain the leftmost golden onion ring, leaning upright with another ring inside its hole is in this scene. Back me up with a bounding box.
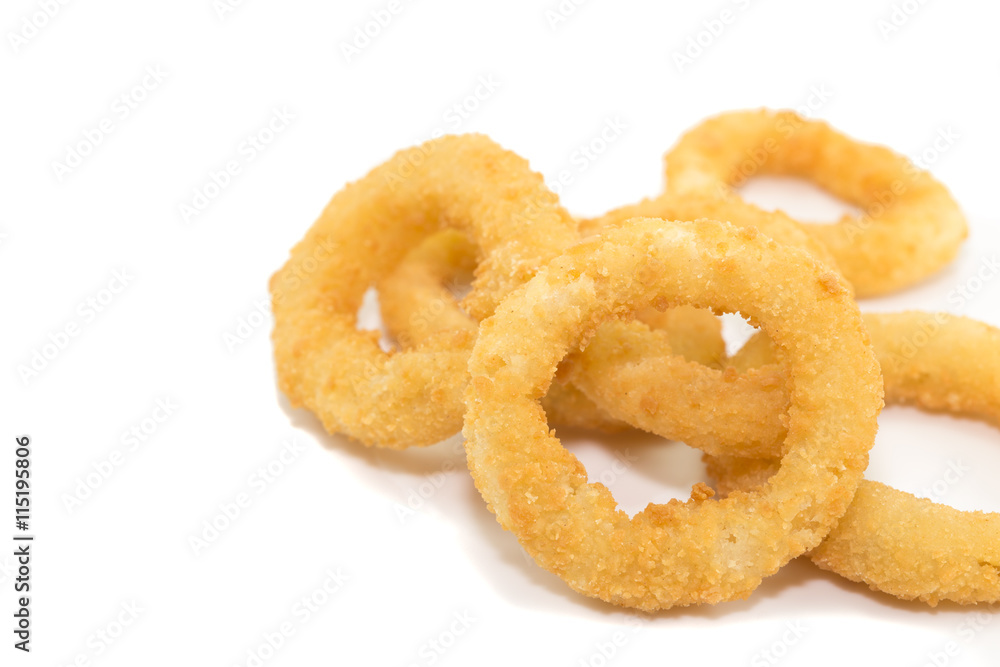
[270,135,578,448]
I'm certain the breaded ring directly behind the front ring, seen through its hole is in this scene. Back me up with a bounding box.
[564,195,834,457]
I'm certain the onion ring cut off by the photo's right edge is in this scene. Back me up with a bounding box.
[705,312,1000,606]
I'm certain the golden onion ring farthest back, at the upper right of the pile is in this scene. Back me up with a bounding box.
[664,109,968,297]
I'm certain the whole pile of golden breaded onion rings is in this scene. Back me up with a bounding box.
[271,110,1000,610]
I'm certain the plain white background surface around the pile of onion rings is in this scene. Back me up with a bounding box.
[0,0,1000,666]
